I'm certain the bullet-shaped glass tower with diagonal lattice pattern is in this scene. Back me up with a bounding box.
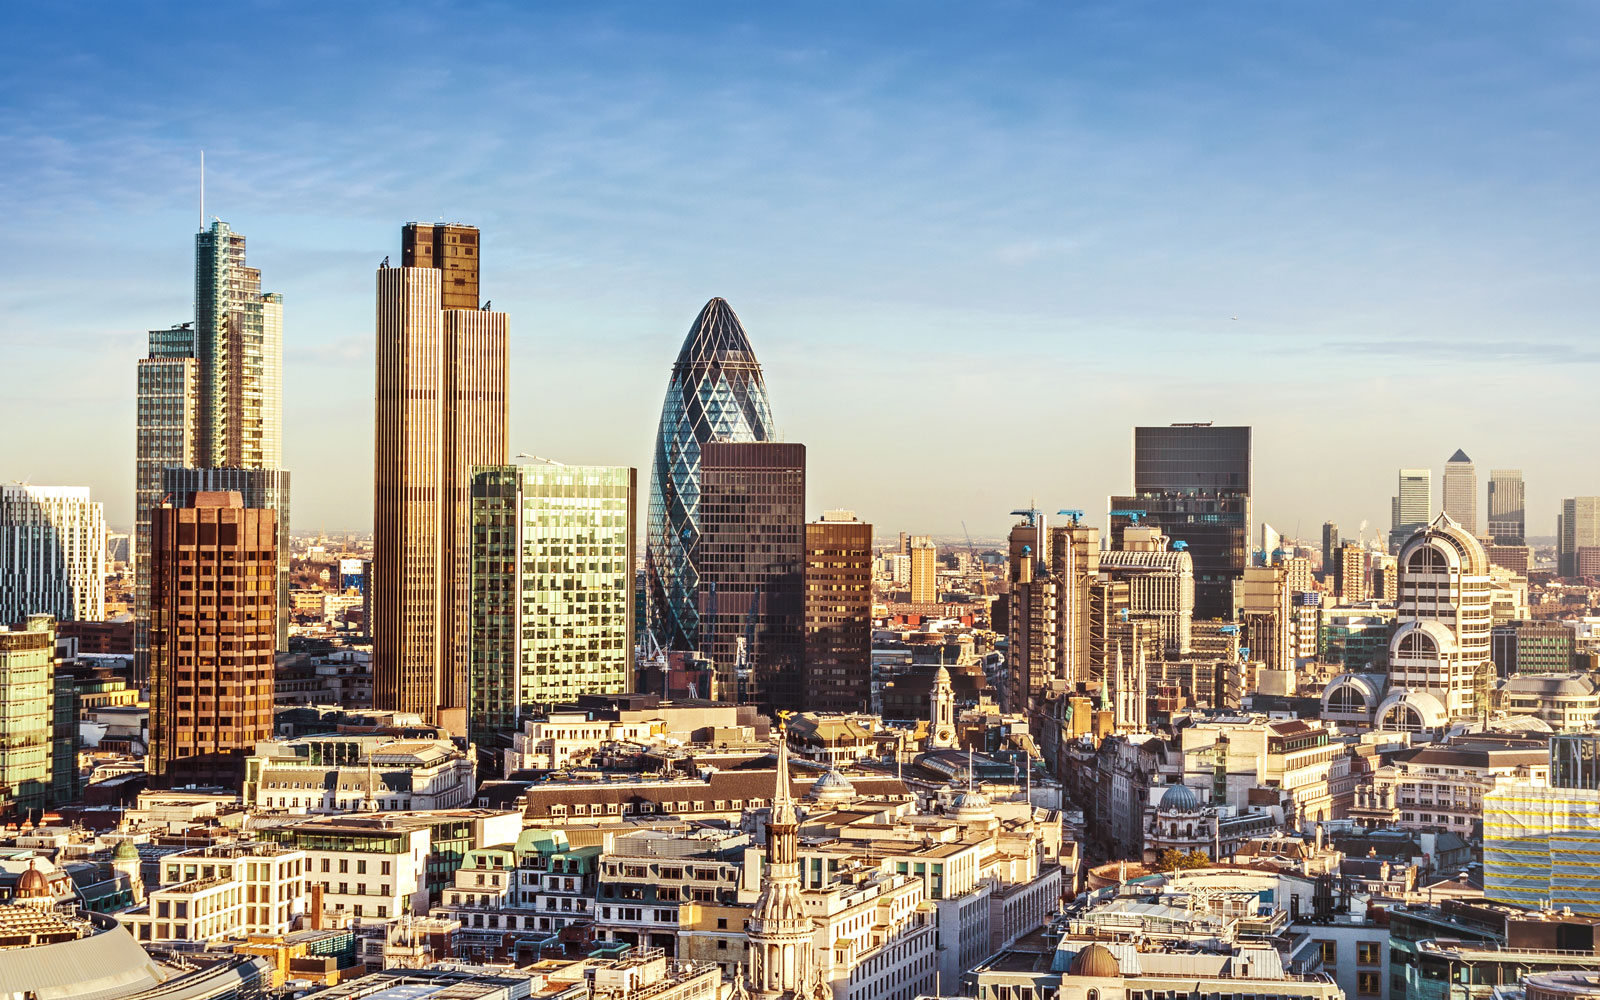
[645,299,776,650]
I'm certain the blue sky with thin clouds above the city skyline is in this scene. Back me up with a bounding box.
[0,3,1600,538]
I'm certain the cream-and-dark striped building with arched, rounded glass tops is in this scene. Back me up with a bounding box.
[1376,514,1494,733]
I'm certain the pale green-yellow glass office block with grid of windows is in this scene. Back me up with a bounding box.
[470,462,638,746]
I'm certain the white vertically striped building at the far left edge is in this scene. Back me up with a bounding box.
[0,483,106,622]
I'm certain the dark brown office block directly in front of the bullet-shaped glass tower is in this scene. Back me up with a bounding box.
[698,442,806,709]
